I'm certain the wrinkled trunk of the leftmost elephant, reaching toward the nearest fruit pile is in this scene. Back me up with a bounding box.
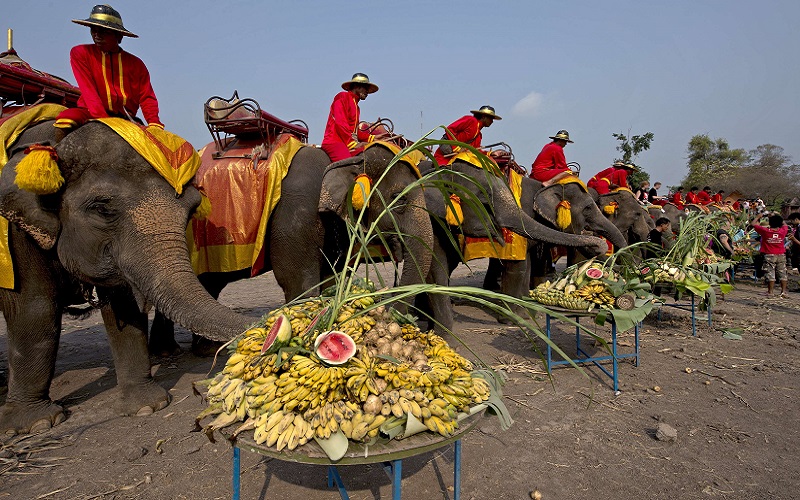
[120,233,247,342]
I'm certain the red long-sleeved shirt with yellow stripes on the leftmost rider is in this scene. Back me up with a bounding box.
[69,44,163,126]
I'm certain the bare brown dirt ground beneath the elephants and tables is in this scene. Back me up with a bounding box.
[0,261,800,500]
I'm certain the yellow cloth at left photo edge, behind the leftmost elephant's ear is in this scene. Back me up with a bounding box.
[0,104,67,290]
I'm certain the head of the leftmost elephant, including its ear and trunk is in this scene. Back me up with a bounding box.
[0,122,250,340]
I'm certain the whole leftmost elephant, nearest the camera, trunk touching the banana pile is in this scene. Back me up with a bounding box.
[0,120,251,434]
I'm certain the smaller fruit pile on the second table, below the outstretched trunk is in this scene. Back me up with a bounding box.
[529,259,620,311]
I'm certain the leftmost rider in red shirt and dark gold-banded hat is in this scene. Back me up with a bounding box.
[54,5,164,140]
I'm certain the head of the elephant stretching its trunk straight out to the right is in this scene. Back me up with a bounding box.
[426,160,607,255]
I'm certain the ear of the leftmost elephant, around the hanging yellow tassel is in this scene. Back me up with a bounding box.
[0,135,61,250]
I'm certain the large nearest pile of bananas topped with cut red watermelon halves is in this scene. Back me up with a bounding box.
[195,282,492,451]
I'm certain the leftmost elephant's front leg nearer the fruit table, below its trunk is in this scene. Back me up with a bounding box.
[101,297,170,416]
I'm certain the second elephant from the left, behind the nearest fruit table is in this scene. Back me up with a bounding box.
[150,139,433,355]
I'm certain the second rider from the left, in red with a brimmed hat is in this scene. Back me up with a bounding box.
[320,73,378,162]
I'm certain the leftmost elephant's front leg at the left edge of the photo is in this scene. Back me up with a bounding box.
[0,296,66,435]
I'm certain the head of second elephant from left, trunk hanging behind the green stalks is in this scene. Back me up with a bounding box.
[319,145,433,285]
